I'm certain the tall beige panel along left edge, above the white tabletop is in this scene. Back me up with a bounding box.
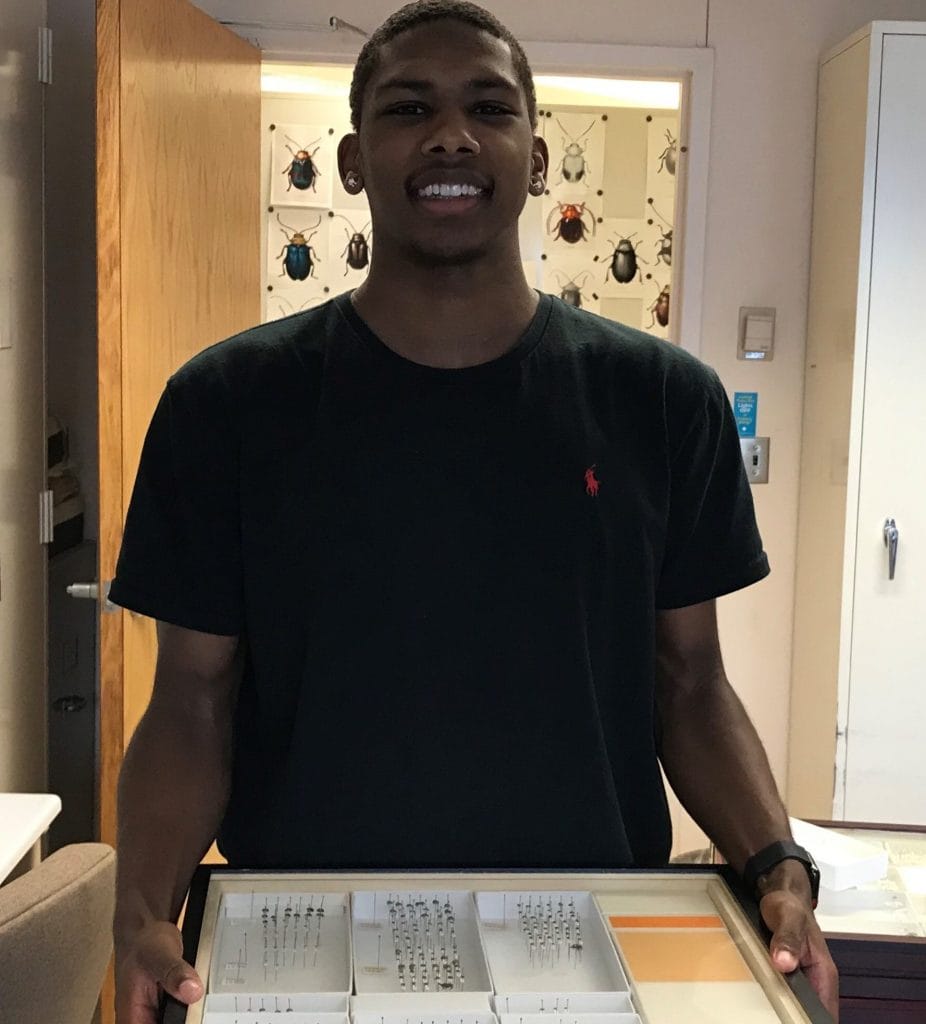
[0,2,47,786]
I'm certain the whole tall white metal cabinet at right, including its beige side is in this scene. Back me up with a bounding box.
[789,23,926,824]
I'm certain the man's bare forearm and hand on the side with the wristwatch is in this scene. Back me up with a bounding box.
[656,601,839,1018]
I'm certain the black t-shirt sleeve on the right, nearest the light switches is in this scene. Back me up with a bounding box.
[656,371,769,608]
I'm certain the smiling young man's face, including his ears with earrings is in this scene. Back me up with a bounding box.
[341,20,546,265]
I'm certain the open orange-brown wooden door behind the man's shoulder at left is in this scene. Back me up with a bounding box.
[96,0,260,843]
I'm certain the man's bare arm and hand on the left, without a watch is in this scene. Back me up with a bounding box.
[115,623,242,1024]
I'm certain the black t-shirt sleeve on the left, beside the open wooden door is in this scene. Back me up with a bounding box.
[110,377,244,636]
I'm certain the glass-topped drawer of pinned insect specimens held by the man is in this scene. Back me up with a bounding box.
[163,866,831,1024]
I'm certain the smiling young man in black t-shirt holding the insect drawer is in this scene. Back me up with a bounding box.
[112,0,836,1024]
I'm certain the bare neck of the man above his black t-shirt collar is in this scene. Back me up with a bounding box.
[352,253,538,369]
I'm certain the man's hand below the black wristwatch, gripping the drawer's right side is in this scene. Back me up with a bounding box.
[759,860,839,1021]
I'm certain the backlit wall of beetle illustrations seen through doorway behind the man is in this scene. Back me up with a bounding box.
[261,74,684,339]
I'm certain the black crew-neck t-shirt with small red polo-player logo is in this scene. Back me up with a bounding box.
[112,295,768,868]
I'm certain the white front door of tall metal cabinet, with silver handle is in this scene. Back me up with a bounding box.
[842,32,926,825]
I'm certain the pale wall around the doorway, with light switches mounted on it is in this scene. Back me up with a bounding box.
[188,0,926,849]
